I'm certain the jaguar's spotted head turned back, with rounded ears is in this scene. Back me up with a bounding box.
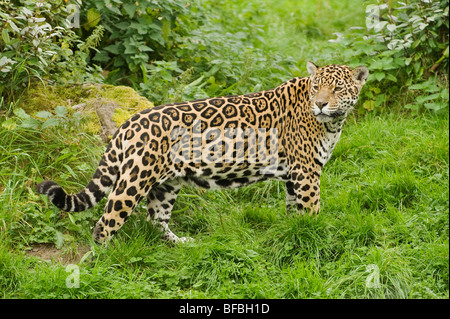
[306,62,369,122]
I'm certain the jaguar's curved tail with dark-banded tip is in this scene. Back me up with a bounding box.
[36,144,118,212]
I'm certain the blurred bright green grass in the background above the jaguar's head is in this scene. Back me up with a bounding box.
[205,0,365,60]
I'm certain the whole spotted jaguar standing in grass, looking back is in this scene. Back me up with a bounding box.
[36,62,369,243]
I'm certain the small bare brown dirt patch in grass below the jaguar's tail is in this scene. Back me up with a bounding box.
[25,244,91,265]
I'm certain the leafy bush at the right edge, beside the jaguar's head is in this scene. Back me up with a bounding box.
[332,0,449,111]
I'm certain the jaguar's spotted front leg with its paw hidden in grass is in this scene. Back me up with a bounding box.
[286,171,320,215]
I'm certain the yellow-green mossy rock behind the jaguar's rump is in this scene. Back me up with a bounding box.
[18,83,154,141]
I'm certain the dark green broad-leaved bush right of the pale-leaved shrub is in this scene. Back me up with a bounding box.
[81,0,187,85]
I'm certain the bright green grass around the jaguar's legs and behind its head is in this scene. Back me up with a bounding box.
[0,0,449,298]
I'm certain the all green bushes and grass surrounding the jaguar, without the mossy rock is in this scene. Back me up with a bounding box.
[0,0,449,298]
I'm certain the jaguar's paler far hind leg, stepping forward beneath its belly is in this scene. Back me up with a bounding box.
[147,180,189,243]
